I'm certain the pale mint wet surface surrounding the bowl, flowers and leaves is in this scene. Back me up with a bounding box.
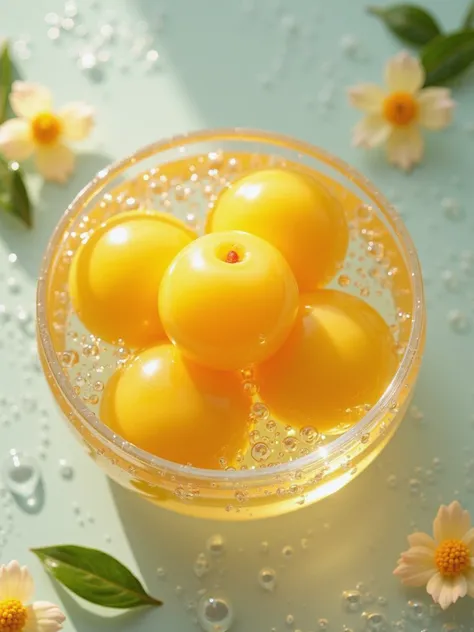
[0,0,474,632]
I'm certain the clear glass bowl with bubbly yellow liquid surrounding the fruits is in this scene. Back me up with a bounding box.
[37,129,425,520]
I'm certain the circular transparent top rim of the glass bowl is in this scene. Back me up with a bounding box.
[37,127,424,485]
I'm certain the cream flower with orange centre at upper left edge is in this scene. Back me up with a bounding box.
[0,81,94,182]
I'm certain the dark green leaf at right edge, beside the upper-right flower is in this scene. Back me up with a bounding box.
[421,30,474,86]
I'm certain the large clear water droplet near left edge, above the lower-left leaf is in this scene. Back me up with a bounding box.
[3,450,44,513]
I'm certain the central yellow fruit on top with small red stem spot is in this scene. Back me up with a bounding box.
[159,231,299,370]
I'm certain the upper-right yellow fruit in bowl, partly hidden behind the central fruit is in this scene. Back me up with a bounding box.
[207,169,349,292]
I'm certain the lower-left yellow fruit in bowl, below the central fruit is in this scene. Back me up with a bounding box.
[100,343,250,469]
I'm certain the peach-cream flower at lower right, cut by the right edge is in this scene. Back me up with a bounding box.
[394,500,474,610]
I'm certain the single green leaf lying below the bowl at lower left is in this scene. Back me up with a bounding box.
[31,545,162,609]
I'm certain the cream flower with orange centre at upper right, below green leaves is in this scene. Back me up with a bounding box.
[349,51,455,170]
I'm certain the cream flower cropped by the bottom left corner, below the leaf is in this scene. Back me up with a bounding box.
[0,561,65,632]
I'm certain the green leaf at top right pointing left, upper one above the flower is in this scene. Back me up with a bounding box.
[367,4,441,46]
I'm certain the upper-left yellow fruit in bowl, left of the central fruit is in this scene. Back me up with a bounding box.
[69,211,196,348]
